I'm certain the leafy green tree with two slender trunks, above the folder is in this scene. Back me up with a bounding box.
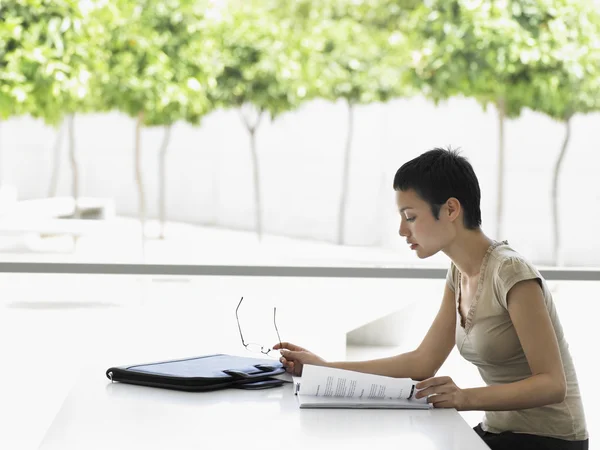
[94,0,216,237]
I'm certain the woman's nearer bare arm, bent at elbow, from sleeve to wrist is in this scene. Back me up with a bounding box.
[464,280,566,411]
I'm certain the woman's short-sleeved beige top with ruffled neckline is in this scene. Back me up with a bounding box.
[446,241,588,441]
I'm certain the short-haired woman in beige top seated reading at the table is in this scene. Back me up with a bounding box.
[273,149,589,450]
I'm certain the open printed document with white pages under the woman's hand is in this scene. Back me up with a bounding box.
[294,365,430,409]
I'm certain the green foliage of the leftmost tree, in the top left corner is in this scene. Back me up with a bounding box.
[0,0,93,125]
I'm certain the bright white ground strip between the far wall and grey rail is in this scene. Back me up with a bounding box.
[0,217,447,267]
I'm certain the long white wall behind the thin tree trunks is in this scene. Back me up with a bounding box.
[0,98,600,266]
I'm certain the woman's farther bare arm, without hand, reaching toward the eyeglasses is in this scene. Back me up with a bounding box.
[326,285,456,380]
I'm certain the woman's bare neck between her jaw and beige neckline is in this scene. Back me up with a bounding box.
[443,228,494,278]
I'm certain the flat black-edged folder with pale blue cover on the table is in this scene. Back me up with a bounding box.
[106,354,285,392]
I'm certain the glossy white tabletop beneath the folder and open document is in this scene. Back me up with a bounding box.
[40,370,488,450]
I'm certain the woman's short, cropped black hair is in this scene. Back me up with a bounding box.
[394,148,481,230]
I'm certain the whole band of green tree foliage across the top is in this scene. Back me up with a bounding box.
[0,0,600,125]
